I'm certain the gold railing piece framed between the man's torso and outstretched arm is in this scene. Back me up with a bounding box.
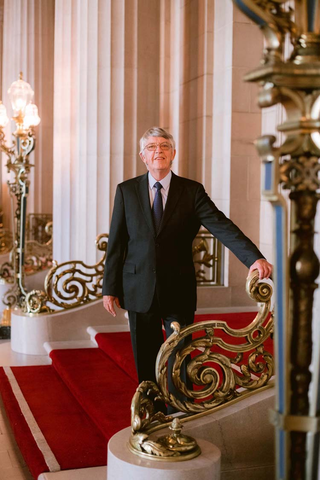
[192,228,223,287]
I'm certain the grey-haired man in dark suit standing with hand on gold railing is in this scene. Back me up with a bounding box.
[102,127,272,390]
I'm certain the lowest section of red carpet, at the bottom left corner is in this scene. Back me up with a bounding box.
[0,365,107,479]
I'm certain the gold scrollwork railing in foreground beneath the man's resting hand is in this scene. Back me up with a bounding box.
[130,271,274,460]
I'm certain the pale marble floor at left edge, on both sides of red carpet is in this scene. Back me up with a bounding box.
[0,340,50,480]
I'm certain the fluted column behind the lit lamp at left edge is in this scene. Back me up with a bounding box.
[2,0,54,225]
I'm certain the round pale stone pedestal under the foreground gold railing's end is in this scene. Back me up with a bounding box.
[107,428,221,480]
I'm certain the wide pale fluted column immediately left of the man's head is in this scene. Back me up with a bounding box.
[54,0,160,263]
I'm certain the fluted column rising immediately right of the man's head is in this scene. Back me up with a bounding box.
[160,0,214,190]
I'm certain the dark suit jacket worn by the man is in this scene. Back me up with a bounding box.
[102,173,263,313]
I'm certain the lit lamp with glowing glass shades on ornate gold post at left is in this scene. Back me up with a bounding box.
[0,73,40,307]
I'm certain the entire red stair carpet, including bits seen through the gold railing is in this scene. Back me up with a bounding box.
[0,313,273,479]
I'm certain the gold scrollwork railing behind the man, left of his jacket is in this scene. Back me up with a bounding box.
[25,233,108,313]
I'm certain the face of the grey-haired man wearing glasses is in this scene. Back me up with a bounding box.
[140,137,176,180]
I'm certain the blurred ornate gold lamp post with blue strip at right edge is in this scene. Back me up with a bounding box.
[234,0,320,479]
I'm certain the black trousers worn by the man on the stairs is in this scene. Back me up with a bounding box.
[129,299,194,408]
